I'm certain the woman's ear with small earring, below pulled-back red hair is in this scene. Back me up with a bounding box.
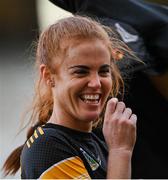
[40,64,55,87]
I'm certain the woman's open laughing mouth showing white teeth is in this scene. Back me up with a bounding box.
[80,94,100,104]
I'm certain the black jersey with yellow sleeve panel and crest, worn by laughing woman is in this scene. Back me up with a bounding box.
[21,123,108,179]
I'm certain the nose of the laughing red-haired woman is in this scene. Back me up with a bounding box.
[88,74,101,89]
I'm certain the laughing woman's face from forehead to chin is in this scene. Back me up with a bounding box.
[53,40,112,130]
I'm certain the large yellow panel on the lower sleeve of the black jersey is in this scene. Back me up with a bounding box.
[39,156,91,179]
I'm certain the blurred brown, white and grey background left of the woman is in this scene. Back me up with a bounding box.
[0,0,168,179]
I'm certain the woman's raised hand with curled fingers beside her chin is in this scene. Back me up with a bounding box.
[103,98,137,152]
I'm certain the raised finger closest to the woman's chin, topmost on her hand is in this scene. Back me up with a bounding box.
[105,98,118,120]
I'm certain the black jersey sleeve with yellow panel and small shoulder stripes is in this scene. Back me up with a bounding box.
[21,127,90,179]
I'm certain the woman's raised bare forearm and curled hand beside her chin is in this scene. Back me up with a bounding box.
[103,98,137,179]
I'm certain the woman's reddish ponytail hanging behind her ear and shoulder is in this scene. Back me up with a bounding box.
[2,73,53,176]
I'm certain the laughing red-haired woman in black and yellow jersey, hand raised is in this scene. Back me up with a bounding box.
[4,16,137,179]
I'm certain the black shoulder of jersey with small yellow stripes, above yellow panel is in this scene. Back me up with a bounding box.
[21,127,78,179]
